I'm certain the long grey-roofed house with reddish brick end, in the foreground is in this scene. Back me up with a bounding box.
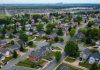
[29,44,51,62]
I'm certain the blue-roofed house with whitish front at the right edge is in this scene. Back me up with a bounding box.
[88,53,100,64]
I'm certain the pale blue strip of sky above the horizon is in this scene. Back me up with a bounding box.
[0,0,100,4]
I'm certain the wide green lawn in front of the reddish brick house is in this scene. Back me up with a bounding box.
[16,59,46,69]
